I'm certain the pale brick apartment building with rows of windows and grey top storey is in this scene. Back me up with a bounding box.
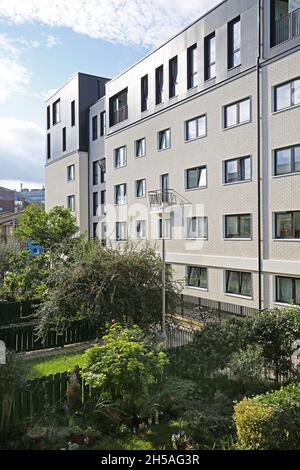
[46,0,300,313]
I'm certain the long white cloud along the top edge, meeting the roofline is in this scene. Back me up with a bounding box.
[0,0,220,47]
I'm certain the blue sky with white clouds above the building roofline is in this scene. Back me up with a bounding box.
[0,0,220,189]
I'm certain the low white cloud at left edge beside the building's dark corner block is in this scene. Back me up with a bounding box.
[0,117,44,183]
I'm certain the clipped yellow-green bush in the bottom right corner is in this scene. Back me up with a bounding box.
[234,385,300,450]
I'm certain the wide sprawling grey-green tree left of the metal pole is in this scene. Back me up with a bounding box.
[37,240,180,336]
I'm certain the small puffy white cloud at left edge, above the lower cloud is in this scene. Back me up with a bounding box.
[0,34,31,104]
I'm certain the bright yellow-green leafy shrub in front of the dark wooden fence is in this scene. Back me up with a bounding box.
[82,324,167,417]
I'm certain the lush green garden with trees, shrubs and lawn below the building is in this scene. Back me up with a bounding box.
[0,203,300,450]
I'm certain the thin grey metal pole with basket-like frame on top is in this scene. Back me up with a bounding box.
[148,189,191,341]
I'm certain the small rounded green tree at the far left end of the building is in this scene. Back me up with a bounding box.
[15,204,78,250]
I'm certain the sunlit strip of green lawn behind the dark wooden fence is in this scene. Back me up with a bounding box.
[26,351,85,380]
